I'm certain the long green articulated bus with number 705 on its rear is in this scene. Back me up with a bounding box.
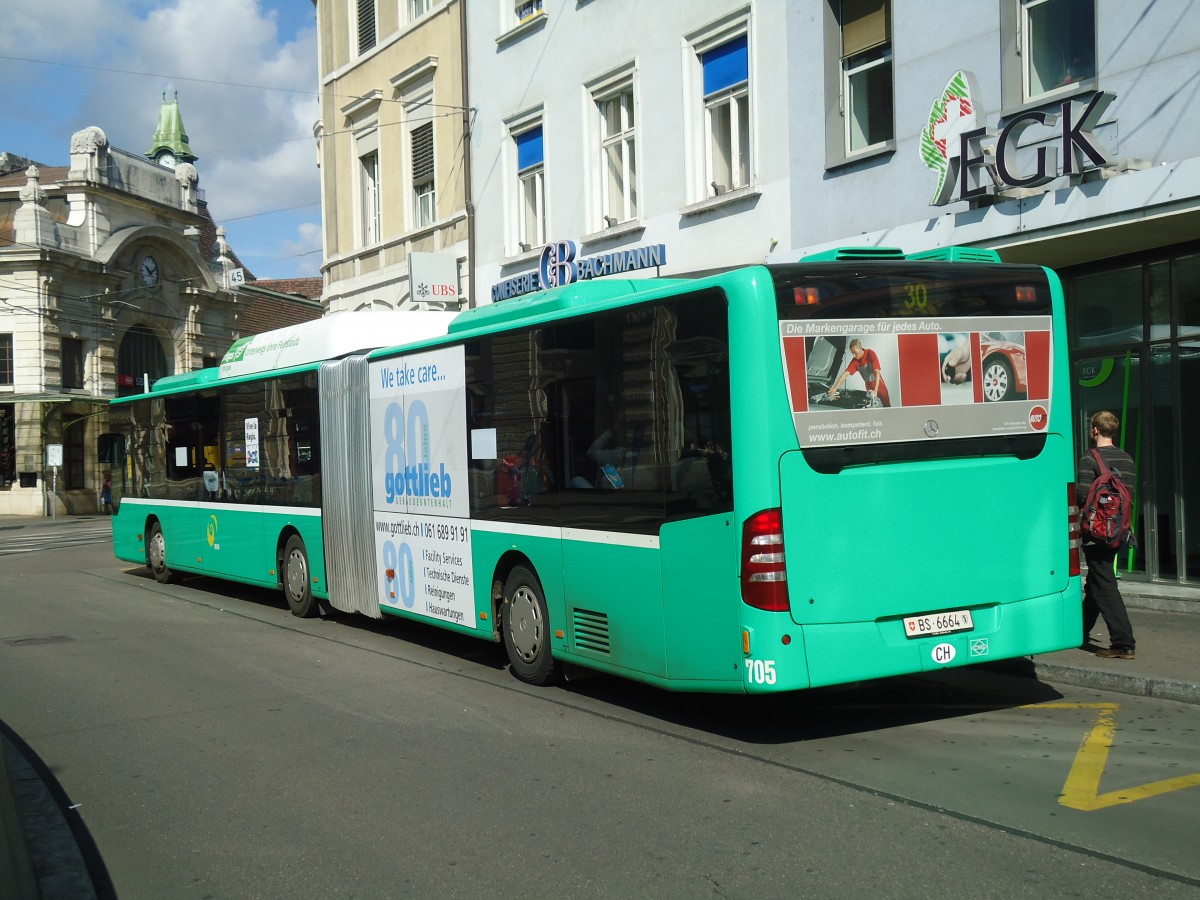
[106,247,1082,692]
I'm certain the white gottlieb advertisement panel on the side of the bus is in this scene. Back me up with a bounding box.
[370,347,475,626]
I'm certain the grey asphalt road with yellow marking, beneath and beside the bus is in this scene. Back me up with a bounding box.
[0,527,1200,898]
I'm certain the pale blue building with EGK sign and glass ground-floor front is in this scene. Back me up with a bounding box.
[773,0,1200,583]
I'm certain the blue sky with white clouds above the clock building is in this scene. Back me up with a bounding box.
[0,0,322,278]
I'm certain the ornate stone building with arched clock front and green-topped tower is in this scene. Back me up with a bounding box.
[0,97,320,516]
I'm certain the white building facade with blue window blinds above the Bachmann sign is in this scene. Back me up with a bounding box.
[467,0,802,302]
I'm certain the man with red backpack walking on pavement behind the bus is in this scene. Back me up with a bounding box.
[1075,410,1136,659]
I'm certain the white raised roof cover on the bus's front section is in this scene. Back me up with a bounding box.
[221,310,457,379]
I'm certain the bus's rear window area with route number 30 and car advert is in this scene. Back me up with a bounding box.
[770,262,1055,461]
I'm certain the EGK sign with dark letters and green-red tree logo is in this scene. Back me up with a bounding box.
[920,71,1116,206]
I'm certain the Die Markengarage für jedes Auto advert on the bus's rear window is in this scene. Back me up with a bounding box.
[779,316,1054,448]
